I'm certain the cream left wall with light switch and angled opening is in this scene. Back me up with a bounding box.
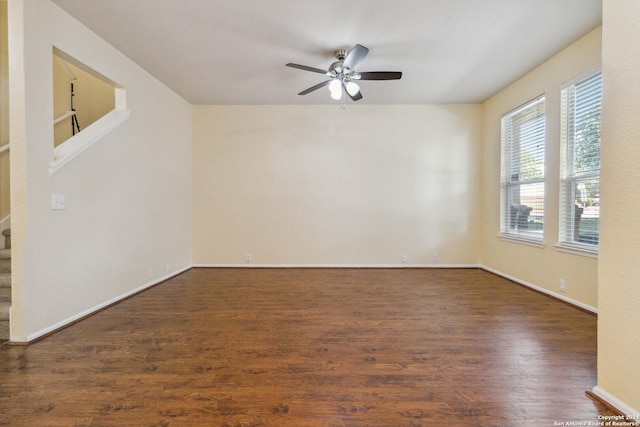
[9,0,192,341]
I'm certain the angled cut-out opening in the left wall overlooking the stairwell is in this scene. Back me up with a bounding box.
[53,47,119,147]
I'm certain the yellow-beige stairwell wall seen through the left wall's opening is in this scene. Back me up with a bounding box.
[53,54,115,147]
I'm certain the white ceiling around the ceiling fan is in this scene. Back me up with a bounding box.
[54,0,602,104]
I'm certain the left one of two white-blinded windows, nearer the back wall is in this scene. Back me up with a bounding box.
[500,96,546,243]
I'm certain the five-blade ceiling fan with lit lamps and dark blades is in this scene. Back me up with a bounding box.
[287,44,402,105]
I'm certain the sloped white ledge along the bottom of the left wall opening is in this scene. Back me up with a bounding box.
[49,110,131,175]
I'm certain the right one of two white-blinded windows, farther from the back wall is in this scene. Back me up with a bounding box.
[559,73,602,251]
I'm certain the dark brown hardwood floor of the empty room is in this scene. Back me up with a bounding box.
[0,269,612,427]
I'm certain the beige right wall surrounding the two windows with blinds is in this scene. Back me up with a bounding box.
[481,28,606,308]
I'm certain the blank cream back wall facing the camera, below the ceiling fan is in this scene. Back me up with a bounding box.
[193,104,481,265]
